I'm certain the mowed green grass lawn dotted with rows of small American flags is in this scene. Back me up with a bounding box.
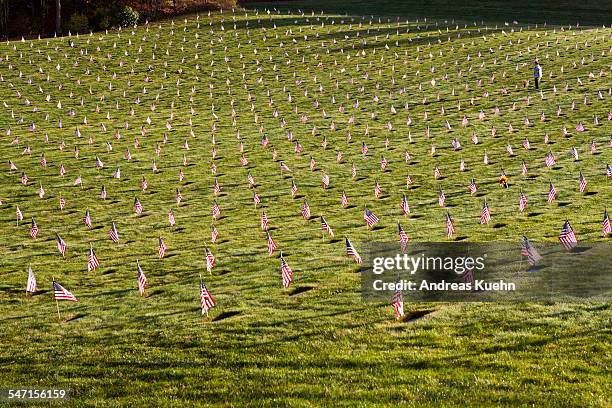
[0,3,612,406]
